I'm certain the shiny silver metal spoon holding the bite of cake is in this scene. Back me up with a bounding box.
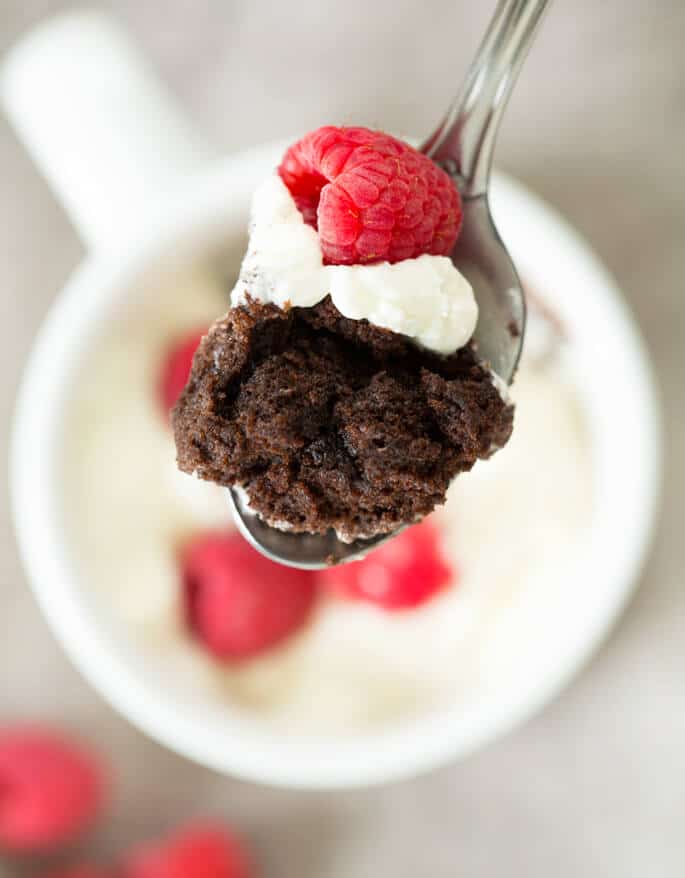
[228,0,549,570]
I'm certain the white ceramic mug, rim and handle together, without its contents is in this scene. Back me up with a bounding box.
[2,13,660,788]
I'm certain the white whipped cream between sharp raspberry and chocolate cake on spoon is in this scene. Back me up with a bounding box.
[231,174,478,354]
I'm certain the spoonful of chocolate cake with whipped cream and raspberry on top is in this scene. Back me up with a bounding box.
[173,126,513,541]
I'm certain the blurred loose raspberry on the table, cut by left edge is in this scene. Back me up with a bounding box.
[0,728,104,850]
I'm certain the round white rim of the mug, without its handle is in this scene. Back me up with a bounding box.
[10,141,661,789]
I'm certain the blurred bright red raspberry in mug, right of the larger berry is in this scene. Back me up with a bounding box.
[320,521,455,610]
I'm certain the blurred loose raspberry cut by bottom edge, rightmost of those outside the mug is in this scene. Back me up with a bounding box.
[122,824,252,878]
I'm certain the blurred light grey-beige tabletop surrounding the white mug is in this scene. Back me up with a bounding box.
[0,0,685,878]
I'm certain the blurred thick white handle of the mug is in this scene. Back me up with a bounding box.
[0,11,215,251]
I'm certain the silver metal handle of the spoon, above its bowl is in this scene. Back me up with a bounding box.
[421,0,549,198]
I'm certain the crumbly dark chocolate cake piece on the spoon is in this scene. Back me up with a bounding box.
[172,298,513,540]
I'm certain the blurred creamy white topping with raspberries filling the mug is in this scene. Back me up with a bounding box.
[65,260,592,735]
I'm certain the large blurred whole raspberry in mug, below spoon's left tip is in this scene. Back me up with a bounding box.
[181,533,317,660]
